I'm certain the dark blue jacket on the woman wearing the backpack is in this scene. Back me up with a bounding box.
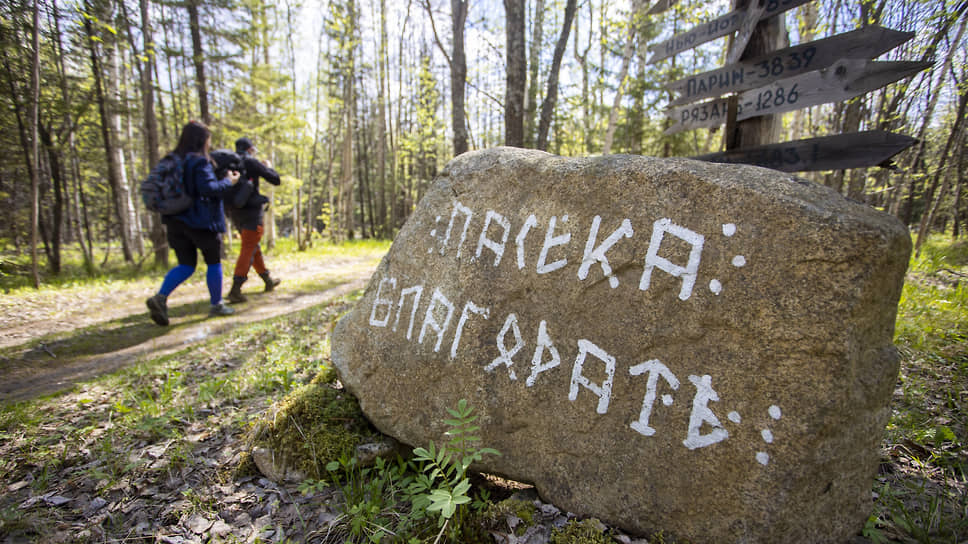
[162,153,235,232]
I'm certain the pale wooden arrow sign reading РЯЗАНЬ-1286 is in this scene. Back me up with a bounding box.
[665,59,932,134]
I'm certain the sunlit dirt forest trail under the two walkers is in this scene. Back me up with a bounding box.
[0,254,382,404]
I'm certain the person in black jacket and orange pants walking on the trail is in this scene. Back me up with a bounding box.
[226,138,280,303]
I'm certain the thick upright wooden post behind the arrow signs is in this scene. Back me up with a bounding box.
[723,0,786,151]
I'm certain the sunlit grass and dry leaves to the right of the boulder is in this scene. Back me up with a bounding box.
[864,235,968,544]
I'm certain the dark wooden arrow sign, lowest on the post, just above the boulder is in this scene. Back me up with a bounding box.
[692,130,917,172]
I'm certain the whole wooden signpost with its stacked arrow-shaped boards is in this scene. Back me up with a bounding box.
[648,0,932,172]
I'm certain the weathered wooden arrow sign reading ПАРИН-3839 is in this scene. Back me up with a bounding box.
[666,25,914,106]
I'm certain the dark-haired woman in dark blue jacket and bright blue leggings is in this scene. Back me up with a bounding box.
[146,121,239,326]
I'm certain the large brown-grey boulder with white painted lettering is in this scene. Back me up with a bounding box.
[333,148,911,544]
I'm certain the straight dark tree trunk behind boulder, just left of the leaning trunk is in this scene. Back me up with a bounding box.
[504,0,528,147]
